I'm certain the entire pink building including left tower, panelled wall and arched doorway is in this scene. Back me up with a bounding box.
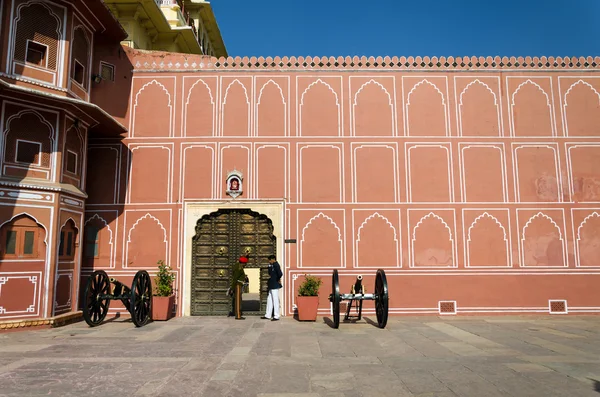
[0,1,600,322]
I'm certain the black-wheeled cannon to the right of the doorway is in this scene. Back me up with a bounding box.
[329,269,389,328]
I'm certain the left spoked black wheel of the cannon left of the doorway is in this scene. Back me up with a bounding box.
[83,270,110,327]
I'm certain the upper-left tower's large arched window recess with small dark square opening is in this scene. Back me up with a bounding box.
[14,3,61,70]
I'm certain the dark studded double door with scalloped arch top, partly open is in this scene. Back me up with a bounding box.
[191,209,277,316]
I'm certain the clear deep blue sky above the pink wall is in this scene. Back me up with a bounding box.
[211,0,600,57]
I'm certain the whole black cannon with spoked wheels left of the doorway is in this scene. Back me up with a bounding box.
[83,270,152,327]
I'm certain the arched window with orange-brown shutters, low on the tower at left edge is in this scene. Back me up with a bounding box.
[0,215,43,259]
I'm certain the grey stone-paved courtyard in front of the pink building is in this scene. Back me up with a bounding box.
[0,316,600,397]
